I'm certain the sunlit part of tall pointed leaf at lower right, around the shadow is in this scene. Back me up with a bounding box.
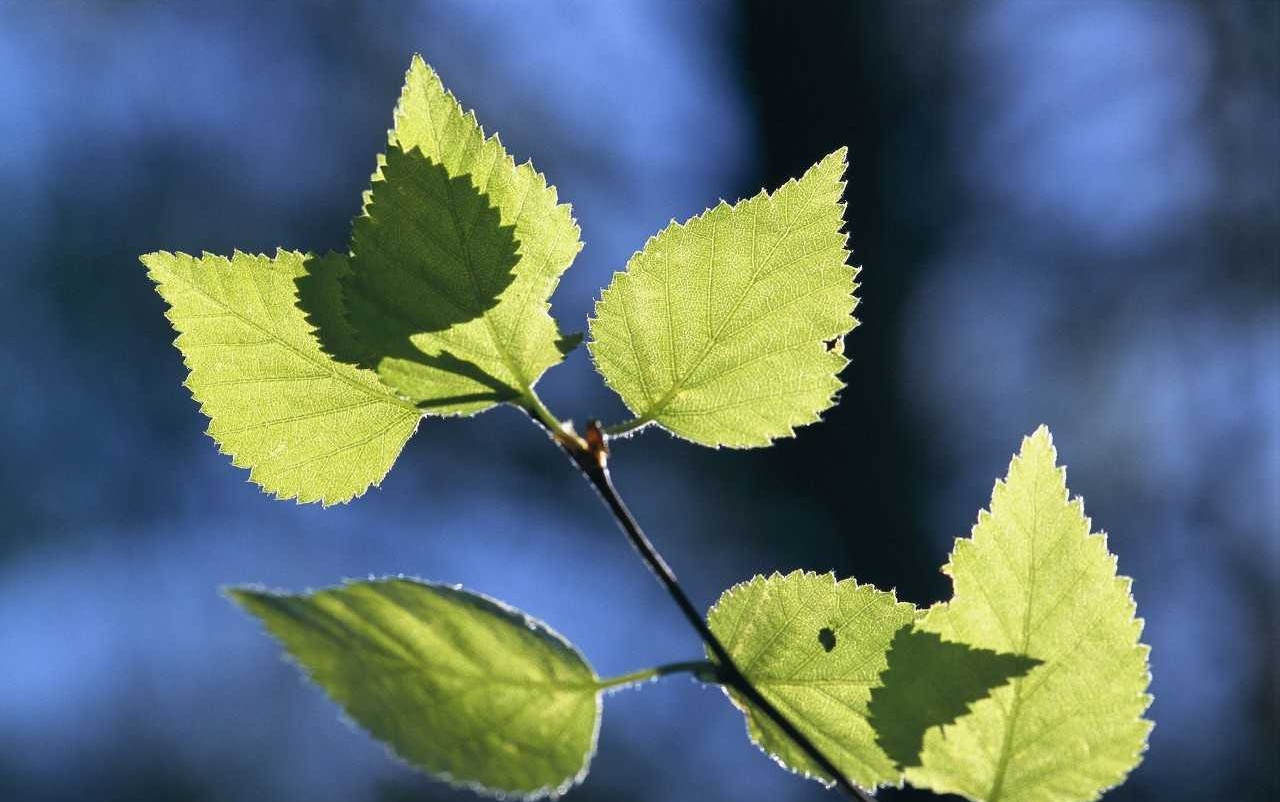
[906,427,1152,802]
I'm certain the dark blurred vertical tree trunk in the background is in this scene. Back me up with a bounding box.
[740,0,956,602]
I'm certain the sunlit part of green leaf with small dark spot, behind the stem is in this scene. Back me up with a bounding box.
[707,570,915,788]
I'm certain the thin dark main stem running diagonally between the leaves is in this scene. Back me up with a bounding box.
[524,406,876,802]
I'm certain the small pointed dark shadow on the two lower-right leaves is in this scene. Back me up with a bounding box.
[868,624,1041,769]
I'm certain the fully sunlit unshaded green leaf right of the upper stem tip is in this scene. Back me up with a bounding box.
[589,148,856,448]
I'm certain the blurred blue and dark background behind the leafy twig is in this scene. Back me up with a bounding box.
[0,0,1280,802]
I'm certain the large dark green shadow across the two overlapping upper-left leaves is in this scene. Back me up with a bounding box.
[297,146,518,409]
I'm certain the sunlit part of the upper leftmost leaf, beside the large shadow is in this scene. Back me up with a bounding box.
[142,251,421,504]
